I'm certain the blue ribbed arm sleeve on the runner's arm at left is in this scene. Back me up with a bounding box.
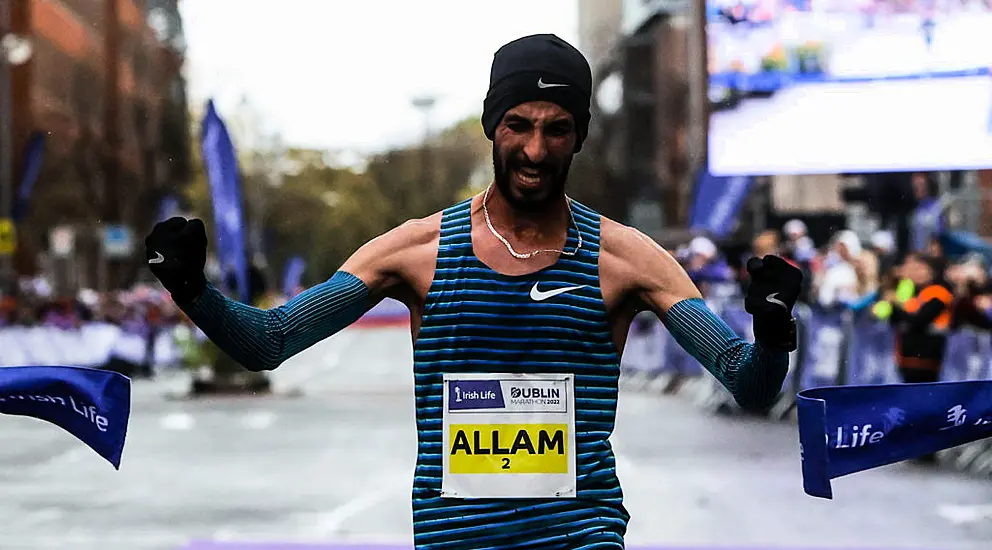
[183,271,369,371]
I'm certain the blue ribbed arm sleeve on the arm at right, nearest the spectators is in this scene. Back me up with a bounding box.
[665,298,789,409]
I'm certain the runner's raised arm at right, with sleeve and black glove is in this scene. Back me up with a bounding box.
[603,222,802,410]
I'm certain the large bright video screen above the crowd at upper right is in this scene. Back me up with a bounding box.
[707,0,992,176]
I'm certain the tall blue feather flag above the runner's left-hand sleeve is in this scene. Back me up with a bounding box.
[200,100,250,303]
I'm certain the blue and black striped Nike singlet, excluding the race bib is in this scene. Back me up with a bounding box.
[413,199,629,549]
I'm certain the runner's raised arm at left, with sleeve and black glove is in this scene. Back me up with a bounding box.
[145,218,432,371]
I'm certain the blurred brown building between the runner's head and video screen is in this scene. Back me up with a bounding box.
[579,0,704,244]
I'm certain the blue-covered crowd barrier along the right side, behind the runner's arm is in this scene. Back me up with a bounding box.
[620,303,992,475]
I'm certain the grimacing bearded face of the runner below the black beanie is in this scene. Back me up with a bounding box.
[493,101,578,211]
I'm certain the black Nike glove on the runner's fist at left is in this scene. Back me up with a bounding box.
[145,217,207,304]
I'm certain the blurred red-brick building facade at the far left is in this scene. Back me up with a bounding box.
[11,0,189,294]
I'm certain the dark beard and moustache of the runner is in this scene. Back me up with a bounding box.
[493,146,572,212]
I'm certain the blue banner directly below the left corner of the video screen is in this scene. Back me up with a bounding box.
[689,168,754,239]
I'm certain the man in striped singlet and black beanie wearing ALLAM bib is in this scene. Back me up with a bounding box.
[145,35,802,549]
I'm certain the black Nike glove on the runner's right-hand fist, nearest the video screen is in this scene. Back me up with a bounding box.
[744,256,803,351]
